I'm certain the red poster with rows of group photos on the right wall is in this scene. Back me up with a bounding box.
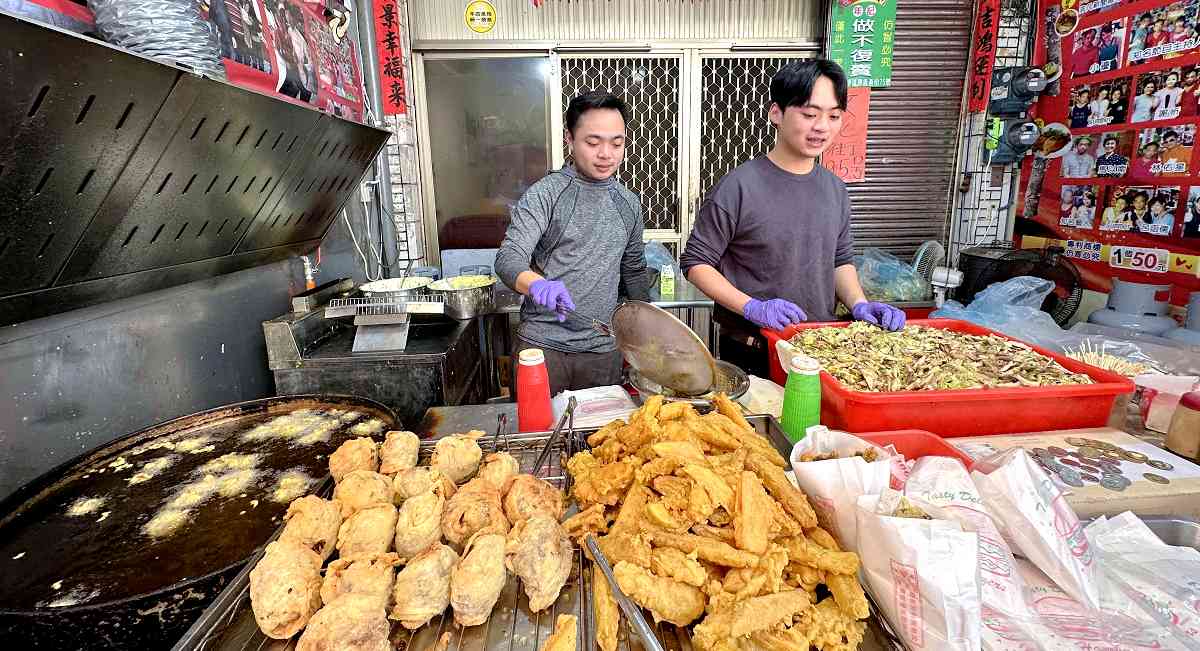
[1015,0,1200,305]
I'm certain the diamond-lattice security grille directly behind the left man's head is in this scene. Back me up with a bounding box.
[562,56,679,231]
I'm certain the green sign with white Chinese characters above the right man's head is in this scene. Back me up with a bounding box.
[829,0,896,88]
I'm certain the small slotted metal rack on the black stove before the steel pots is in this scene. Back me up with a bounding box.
[325,294,445,353]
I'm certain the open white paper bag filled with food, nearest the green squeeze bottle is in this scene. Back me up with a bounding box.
[791,425,892,553]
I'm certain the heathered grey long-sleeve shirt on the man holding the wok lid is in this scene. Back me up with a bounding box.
[496,166,649,352]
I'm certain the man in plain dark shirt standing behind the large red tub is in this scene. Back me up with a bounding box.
[680,59,905,377]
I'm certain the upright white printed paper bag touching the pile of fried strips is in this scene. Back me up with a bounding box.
[856,489,982,651]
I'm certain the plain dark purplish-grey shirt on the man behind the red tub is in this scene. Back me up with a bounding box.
[679,156,854,332]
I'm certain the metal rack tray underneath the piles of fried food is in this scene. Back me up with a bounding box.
[174,416,904,651]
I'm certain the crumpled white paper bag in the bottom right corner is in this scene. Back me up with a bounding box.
[1086,512,1200,650]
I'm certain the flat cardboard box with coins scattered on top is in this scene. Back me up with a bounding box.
[947,428,1200,519]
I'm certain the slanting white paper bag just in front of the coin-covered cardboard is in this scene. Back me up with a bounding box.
[971,448,1099,608]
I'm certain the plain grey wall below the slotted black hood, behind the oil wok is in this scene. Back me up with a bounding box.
[0,219,362,498]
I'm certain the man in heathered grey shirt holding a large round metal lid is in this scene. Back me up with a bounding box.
[496,92,649,395]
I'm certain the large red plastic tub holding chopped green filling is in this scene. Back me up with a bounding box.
[762,318,1134,436]
